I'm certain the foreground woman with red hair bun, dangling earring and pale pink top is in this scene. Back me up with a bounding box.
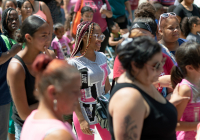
[21,54,81,140]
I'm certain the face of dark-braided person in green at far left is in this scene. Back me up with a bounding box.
[6,10,19,32]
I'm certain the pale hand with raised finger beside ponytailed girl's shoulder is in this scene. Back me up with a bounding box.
[169,84,190,106]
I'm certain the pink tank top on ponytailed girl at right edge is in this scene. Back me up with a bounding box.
[176,79,200,140]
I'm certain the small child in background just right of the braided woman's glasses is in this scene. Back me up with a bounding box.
[108,23,124,50]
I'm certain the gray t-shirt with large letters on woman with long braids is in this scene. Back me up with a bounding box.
[68,52,110,125]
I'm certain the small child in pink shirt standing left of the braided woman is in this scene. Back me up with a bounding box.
[51,23,72,60]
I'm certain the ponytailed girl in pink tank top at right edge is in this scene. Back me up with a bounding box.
[171,42,200,140]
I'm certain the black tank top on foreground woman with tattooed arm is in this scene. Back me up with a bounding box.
[108,83,177,140]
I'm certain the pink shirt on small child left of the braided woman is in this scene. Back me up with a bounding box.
[51,35,70,59]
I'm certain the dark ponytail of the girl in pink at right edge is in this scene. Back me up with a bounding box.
[171,66,184,88]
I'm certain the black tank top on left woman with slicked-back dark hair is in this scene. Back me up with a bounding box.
[12,55,38,126]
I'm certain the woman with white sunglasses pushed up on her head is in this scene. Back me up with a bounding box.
[159,13,185,64]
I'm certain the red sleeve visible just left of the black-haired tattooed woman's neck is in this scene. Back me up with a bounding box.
[113,56,125,79]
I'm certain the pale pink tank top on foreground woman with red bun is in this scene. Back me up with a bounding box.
[20,110,77,140]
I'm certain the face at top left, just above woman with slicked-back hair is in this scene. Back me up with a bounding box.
[21,1,33,19]
